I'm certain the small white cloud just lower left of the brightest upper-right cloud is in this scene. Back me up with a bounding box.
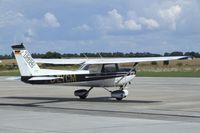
[139,18,160,30]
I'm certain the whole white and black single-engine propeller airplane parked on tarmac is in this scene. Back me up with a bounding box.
[12,43,189,100]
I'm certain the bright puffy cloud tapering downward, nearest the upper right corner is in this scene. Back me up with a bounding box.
[159,5,182,30]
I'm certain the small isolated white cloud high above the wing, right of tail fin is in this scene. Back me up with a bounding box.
[44,12,60,27]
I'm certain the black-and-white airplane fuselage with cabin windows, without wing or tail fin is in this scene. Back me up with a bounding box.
[21,64,135,87]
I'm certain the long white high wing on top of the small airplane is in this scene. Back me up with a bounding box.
[35,56,190,65]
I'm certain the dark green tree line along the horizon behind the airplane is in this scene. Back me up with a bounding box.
[0,51,200,59]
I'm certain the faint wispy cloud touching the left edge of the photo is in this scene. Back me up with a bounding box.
[0,11,24,28]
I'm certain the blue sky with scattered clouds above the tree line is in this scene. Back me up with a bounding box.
[0,0,200,54]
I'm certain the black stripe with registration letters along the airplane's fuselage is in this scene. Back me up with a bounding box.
[21,72,133,84]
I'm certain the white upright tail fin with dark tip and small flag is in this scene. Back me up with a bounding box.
[12,43,40,76]
